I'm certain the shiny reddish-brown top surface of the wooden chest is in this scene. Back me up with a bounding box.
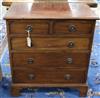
[5,2,98,19]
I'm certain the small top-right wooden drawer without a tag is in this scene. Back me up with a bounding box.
[54,20,93,34]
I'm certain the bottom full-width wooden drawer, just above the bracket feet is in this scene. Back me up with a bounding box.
[13,68,86,84]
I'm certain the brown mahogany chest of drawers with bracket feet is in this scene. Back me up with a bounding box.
[5,3,98,96]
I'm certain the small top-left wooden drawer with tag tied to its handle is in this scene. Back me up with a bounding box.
[10,20,49,34]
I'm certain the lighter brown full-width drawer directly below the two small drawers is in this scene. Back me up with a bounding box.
[11,37,90,50]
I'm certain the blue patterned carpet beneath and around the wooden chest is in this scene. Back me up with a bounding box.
[0,22,100,98]
